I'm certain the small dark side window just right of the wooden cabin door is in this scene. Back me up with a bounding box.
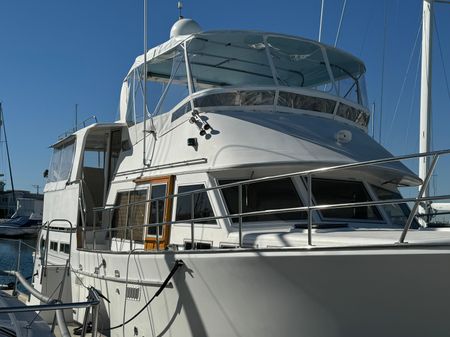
[176,184,216,224]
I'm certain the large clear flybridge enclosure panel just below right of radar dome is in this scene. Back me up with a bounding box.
[188,32,274,88]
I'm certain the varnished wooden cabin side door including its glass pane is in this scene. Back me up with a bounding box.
[135,176,175,250]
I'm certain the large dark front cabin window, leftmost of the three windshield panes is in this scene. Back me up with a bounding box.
[219,178,306,223]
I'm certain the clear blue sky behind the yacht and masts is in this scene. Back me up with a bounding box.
[0,0,450,193]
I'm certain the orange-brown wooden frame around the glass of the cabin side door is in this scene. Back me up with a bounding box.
[134,175,175,250]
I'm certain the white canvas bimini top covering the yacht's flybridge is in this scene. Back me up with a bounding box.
[121,19,367,121]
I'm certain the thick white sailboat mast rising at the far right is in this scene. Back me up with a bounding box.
[419,0,434,201]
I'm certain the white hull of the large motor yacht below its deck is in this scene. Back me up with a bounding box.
[67,246,450,337]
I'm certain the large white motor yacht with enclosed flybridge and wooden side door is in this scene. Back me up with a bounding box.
[24,1,450,337]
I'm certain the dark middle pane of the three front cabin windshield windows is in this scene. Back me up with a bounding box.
[312,178,382,220]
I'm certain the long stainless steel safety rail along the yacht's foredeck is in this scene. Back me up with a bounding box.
[83,150,450,250]
